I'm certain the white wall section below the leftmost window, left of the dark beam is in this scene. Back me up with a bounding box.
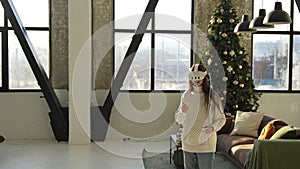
[0,92,54,139]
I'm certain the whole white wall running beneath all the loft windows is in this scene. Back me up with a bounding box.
[0,91,300,139]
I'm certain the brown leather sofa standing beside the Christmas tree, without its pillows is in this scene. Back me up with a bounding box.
[217,116,288,168]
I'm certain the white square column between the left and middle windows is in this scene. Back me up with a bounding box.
[68,0,92,144]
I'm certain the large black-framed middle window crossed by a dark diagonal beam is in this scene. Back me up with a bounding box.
[114,0,193,91]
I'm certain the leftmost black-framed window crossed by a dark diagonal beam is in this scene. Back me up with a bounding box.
[0,0,50,91]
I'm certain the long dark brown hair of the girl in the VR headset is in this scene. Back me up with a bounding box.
[188,64,210,106]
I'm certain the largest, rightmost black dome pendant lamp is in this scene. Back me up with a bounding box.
[263,2,292,25]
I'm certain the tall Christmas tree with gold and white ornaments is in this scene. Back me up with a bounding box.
[201,0,261,115]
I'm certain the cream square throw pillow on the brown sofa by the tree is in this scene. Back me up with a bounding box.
[230,111,264,137]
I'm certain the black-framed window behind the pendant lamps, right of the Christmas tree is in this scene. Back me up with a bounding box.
[252,0,300,92]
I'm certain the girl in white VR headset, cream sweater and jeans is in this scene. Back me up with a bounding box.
[175,64,226,169]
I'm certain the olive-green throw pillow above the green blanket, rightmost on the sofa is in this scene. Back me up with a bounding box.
[270,125,297,140]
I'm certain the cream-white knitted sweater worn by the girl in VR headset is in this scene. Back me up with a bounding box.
[175,88,226,153]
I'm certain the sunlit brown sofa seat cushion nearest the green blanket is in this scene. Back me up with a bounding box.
[230,144,253,165]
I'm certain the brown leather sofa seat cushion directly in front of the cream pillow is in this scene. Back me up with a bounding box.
[217,134,255,153]
